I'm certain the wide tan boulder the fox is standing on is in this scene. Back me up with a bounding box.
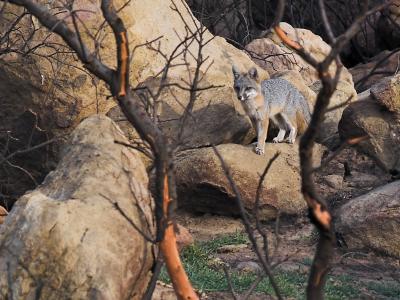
[175,143,321,220]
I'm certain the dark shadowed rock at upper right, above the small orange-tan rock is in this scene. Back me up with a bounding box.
[349,50,400,93]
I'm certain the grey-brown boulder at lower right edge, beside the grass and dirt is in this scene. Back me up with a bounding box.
[336,181,400,257]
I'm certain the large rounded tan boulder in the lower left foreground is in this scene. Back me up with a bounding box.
[0,116,154,299]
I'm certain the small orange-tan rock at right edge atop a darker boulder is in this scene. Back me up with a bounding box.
[371,74,400,116]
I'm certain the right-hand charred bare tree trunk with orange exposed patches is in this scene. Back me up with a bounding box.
[274,0,393,299]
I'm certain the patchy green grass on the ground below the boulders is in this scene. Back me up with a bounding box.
[160,233,390,300]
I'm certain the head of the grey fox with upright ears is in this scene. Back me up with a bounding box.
[232,66,260,101]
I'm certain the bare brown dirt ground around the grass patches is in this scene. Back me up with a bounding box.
[178,149,400,299]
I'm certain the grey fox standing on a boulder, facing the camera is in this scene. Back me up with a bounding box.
[232,66,311,155]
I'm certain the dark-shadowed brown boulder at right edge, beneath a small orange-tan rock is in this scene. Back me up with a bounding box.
[339,98,400,172]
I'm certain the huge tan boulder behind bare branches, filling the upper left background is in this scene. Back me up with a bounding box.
[0,0,268,204]
